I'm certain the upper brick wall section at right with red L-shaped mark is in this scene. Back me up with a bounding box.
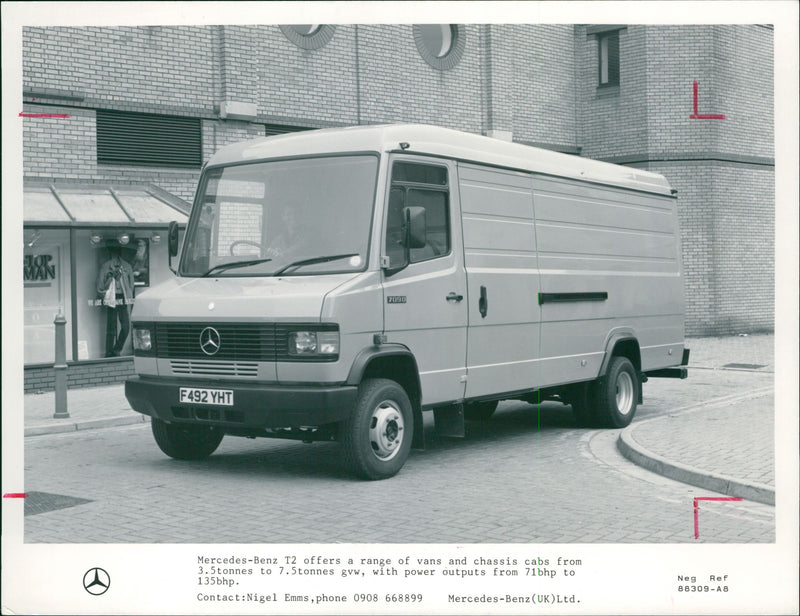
[640,26,774,159]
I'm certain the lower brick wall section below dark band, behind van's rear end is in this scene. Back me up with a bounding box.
[647,161,775,336]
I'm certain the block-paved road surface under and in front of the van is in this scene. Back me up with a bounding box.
[20,410,775,544]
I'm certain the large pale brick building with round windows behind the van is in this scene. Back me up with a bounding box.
[17,24,775,384]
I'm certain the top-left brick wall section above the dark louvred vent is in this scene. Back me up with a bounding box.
[22,26,219,115]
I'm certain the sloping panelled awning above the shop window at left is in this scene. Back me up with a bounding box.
[23,182,191,227]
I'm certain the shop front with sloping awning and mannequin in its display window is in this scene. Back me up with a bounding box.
[23,182,189,391]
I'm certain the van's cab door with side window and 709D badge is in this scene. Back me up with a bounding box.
[382,155,468,405]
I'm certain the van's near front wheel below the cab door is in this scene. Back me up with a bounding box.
[339,379,414,480]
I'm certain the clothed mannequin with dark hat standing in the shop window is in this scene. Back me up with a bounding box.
[97,247,133,357]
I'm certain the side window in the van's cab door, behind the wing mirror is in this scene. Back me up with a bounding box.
[386,162,450,263]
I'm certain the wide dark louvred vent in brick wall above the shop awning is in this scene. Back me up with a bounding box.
[97,110,203,168]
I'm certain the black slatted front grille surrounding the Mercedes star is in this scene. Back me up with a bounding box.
[155,323,285,360]
